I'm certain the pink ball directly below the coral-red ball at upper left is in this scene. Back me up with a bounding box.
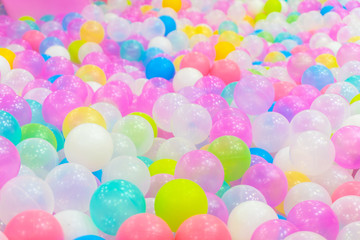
[13,50,45,78]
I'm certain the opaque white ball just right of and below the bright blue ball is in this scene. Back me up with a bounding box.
[173,68,203,92]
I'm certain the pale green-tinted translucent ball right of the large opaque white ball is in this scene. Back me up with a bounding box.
[112,115,154,156]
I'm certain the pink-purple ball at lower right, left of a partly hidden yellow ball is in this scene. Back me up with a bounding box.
[241,163,288,207]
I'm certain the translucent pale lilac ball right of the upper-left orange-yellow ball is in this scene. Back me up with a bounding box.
[106,17,131,42]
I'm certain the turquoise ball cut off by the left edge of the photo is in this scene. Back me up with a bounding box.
[0,110,21,145]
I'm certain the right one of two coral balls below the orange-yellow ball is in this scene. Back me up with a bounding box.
[209,59,241,85]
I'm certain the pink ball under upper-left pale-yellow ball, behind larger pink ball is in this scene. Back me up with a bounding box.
[50,75,88,102]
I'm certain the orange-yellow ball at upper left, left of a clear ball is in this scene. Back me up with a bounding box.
[80,21,105,43]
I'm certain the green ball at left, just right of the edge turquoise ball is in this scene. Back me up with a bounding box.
[21,123,57,149]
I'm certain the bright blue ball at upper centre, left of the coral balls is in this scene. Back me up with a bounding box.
[145,57,175,80]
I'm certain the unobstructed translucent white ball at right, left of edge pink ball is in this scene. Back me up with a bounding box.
[290,131,335,176]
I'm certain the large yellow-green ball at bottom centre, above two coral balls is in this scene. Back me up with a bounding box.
[154,179,208,232]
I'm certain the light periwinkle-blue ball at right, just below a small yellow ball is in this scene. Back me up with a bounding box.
[301,65,335,91]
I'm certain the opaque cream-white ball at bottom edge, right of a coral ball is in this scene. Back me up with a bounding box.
[228,201,277,240]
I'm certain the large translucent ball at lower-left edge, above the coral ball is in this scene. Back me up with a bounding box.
[0,176,54,223]
